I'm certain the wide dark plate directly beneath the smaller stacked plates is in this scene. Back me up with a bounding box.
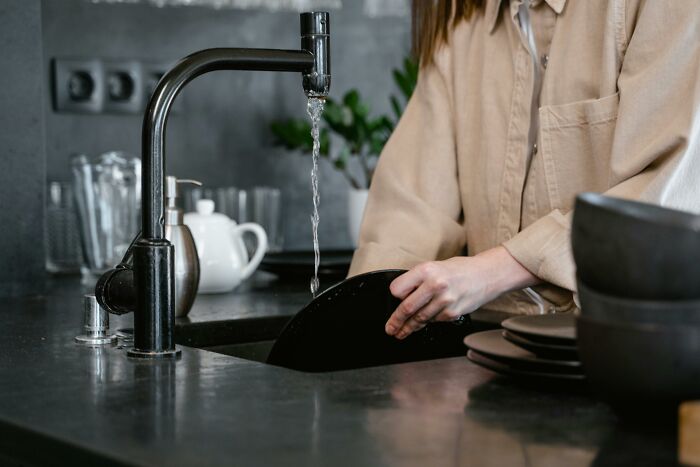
[464,329,582,374]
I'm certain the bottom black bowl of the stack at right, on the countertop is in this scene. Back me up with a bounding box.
[576,316,700,417]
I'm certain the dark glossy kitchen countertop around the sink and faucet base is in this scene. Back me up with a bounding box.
[0,275,675,467]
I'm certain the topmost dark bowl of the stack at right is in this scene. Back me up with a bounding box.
[571,193,700,300]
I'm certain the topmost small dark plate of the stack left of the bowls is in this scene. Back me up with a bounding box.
[501,313,576,346]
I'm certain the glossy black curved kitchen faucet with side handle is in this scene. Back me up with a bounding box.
[95,12,331,358]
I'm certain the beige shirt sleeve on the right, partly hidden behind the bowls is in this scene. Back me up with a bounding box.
[504,0,700,290]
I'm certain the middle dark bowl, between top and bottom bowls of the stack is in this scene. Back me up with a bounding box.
[578,279,700,326]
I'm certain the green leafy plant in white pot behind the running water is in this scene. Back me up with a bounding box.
[270,54,418,189]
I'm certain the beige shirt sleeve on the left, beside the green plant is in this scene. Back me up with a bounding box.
[350,54,465,276]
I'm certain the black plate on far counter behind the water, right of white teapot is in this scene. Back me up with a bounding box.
[259,250,354,279]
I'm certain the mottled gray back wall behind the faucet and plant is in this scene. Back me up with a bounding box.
[43,0,409,248]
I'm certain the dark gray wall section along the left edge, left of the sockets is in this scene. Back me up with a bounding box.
[0,0,46,297]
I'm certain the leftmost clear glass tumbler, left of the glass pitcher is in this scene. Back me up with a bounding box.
[45,182,80,274]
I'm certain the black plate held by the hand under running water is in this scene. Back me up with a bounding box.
[268,270,471,372]
